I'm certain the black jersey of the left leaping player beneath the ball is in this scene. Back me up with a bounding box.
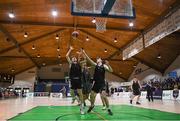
[69,63,81,79]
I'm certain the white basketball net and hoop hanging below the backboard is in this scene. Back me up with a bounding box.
[95,18,107,33]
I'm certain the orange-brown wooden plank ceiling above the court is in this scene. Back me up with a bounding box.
[0,0,180,80]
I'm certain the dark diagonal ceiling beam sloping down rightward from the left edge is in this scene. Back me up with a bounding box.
[0,24,39,68]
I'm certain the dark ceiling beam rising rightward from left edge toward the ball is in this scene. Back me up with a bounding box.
[0,28,65,54]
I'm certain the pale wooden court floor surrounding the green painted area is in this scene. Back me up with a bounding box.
[0,97,180,121]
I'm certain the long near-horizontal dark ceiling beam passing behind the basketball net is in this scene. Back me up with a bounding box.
[0,20,141,32]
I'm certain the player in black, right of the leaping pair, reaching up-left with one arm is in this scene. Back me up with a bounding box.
[82,50,113,115]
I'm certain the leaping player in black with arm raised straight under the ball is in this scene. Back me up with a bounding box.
[66,47,84,114]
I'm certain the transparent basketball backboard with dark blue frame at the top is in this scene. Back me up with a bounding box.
[71,0,136,19]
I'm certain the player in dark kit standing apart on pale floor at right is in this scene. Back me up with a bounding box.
[130,77,141,105]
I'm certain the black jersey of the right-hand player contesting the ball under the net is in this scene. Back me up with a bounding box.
[94,65,105,84]
